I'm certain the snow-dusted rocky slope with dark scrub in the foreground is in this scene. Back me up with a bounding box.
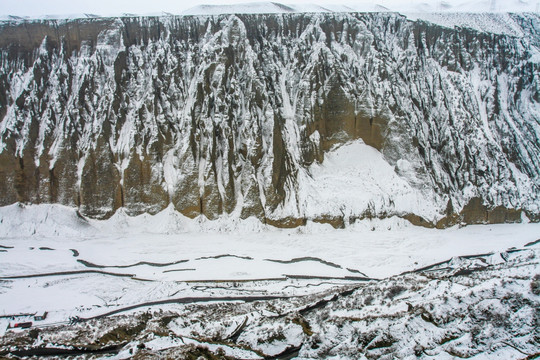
[0,244,540,359]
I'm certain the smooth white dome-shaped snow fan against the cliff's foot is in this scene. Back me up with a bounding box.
[300,140,442,220]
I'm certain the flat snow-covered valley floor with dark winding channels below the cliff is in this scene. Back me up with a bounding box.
[0,205,540,334]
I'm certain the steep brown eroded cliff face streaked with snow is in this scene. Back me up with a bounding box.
[0,13,540,227]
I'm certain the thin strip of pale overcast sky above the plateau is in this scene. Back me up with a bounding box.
[0,0,540,16]
